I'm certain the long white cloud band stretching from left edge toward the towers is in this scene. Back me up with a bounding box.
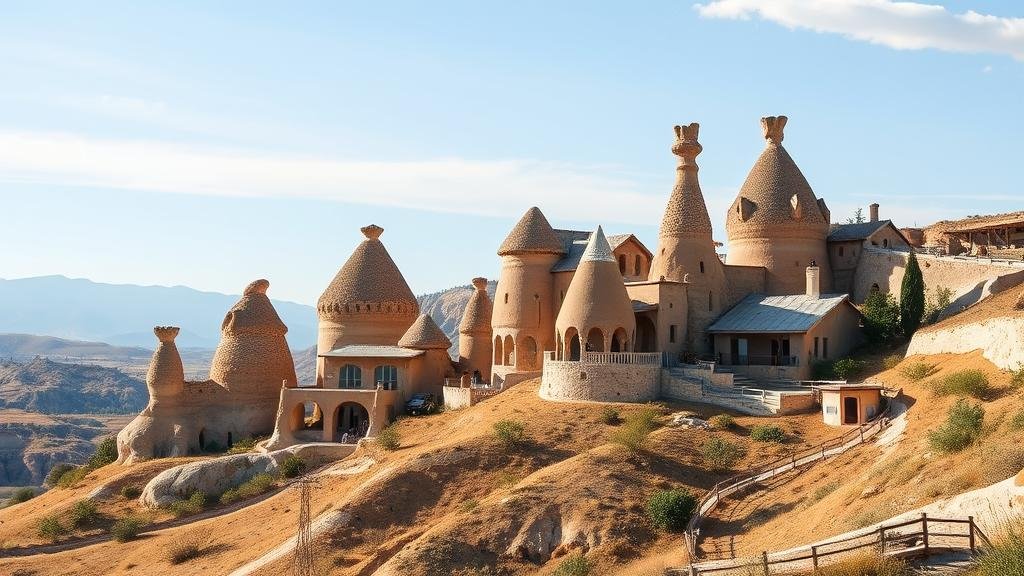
[0,132,665,224]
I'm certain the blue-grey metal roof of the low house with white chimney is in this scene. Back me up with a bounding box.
[708,294,852,333]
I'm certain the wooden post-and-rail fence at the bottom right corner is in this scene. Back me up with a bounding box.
[667,513,991,576]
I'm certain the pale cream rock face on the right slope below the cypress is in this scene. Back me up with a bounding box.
[906,318,1024,370]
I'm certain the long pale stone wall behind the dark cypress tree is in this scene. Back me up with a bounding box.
[851,247,1024,308]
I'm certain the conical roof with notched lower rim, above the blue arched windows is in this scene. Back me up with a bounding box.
[316,224,420,319]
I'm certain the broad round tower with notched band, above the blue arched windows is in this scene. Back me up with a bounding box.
[316,224,420,380]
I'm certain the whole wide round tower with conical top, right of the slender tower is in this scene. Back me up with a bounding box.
[725,116,831,294]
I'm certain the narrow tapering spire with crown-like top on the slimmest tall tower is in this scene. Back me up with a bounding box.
[658,122,712,238]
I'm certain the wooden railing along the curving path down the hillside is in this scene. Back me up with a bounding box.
[685,402,892,559]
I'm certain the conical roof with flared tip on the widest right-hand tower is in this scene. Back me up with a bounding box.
[726,116,828,238]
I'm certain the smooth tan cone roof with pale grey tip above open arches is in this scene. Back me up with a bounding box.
[555,227,636,339]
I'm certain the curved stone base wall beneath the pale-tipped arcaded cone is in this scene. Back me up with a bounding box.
[540,360,662,402]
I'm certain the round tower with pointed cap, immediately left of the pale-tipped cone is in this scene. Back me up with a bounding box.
[490,206,565,377]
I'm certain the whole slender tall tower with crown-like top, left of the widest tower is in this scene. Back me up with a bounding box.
[649,122,725,354]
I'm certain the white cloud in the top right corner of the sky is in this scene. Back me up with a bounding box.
[694,0,1024,60]
